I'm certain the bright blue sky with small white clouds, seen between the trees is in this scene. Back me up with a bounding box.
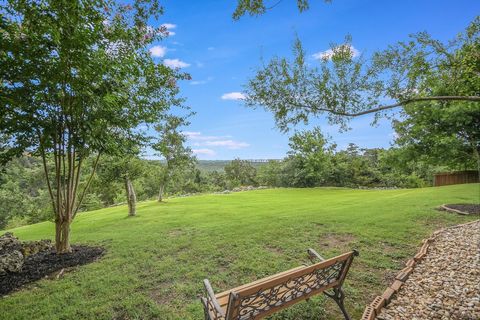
[145,0,480,159]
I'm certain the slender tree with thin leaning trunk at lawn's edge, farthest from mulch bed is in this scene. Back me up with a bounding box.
[152,115,196,202]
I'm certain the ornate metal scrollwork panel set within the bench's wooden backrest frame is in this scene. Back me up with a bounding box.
[237,261,346,320]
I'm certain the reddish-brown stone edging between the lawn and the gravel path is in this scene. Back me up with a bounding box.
[361,220,480,320]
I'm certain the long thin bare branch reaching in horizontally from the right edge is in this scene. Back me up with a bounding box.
[294,96,480,117]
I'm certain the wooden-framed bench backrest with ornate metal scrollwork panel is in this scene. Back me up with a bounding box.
[225,251,356,320]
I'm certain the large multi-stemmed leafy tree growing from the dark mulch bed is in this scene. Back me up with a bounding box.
[0,0,187,253]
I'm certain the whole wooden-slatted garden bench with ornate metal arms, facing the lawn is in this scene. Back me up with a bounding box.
[201,249,358,320]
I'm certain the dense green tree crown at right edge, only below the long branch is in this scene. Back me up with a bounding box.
[394,103,480,171]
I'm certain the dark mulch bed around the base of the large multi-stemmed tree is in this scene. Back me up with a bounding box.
[0,246,104,297]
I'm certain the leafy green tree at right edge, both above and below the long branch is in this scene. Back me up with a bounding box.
[394,27,480,174]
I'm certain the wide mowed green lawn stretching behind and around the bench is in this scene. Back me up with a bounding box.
[0,184,480,320]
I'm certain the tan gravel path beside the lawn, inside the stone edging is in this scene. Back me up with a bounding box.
[376,221,480,320]
